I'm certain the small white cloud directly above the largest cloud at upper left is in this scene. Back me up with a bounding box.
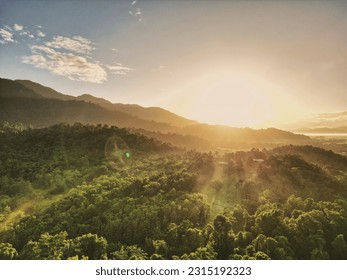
[46,36,95,54]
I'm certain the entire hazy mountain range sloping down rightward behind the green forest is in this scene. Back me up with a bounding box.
[0,76,311,149]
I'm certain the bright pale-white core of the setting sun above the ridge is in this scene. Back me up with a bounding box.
[196,74,273,127]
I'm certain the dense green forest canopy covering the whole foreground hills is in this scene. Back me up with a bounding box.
[0,123,347,260]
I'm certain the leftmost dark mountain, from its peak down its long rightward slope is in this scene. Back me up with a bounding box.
[0,79,174,131]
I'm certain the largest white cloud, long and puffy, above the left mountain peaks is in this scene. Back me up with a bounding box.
[22,45,107,83]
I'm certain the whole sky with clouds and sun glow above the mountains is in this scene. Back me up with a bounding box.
[0,0,347,128]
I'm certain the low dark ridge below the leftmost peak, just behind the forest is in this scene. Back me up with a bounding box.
[0,97,178,131]
